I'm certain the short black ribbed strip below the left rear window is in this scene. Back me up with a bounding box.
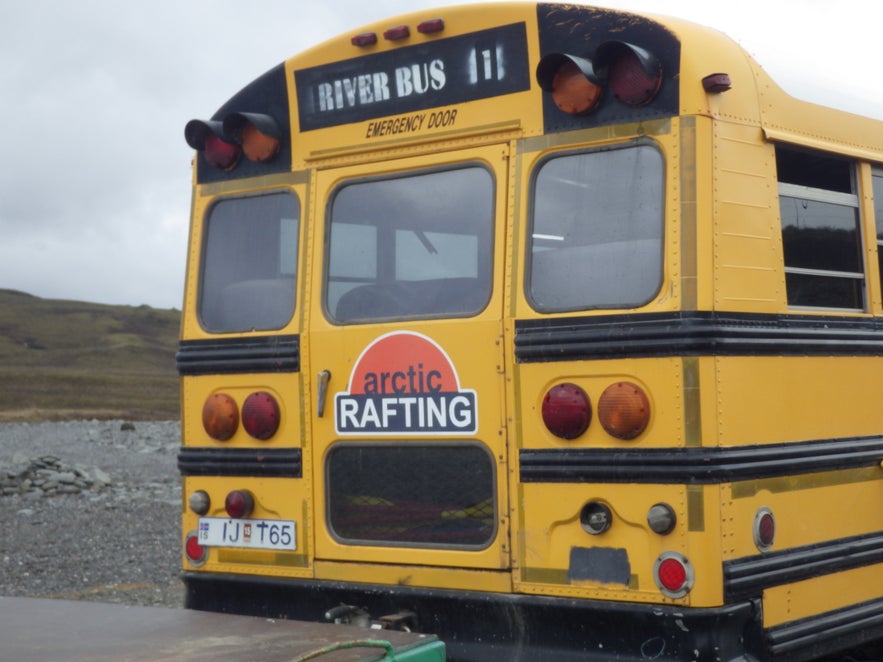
[175,335,300,376]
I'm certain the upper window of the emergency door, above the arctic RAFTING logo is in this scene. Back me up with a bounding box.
[325,166,494,323]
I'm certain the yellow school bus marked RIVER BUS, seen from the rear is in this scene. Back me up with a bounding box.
[177,3,883,660]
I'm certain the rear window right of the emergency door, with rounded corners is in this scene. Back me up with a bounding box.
[526,145,664,312]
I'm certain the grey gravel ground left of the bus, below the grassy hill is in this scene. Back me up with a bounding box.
[0,421,183,607]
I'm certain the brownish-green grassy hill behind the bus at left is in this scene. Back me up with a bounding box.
[0,289,181,421]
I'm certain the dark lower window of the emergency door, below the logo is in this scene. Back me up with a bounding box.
[326,444,496,548]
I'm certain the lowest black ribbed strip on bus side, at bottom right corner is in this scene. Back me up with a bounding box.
[766,598,883,661]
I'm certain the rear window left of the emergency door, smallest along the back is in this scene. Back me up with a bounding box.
[199,192,300,333]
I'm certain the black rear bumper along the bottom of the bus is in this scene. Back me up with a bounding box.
[183,572,765,662]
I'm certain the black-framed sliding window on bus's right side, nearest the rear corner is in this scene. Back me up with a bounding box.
[776,146,865,310]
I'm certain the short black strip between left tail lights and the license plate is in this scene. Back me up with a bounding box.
[178,448,303,478]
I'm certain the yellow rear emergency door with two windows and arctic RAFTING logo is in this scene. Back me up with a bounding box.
[309,145,509,576]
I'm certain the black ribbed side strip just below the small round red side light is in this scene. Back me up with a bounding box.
[724,531,883,602]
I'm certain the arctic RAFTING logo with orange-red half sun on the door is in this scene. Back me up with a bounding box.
[334,331,478,435]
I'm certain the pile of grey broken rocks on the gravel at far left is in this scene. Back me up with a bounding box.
[0,455,111,497]
